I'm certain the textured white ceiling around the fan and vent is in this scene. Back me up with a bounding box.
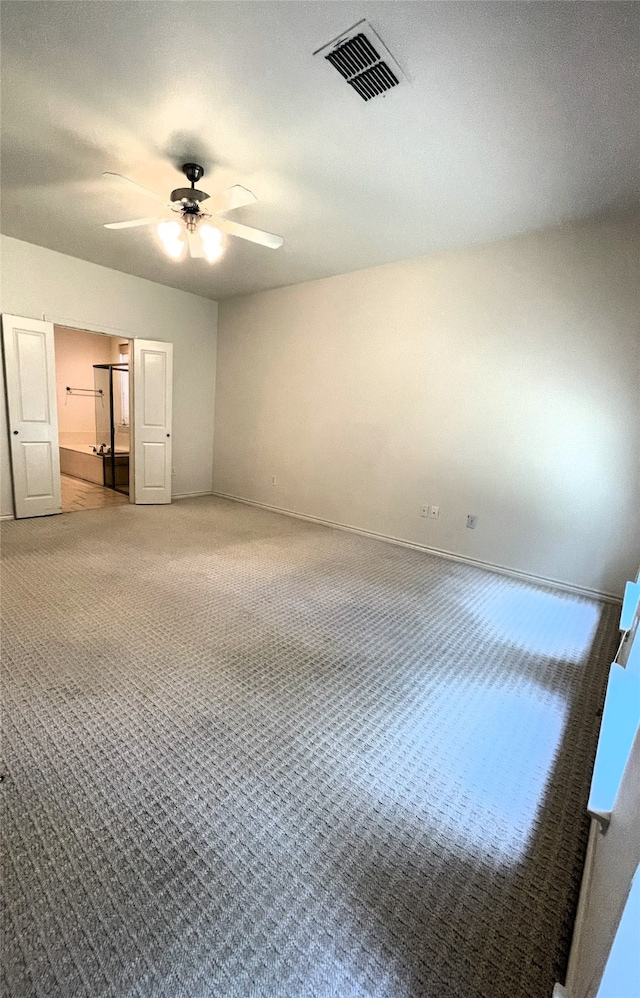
[1,0,640,299]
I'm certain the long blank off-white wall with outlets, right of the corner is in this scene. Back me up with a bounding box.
[214,220,640,594]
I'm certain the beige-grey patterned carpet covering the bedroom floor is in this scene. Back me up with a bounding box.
[0,498,618,998]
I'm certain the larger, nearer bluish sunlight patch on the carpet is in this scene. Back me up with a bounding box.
[356,680,566,863]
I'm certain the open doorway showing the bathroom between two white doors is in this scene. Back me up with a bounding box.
[54,325,132,513]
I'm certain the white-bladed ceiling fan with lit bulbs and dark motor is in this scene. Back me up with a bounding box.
[103,163,284,263]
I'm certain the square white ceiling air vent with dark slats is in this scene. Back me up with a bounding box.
[313,20,403,100]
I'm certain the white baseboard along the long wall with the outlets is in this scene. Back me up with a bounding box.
[212,489,622,603]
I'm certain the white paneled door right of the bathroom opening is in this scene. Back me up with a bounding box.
[133,340,173,503]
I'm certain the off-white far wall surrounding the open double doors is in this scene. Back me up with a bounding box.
[0,236,217,515]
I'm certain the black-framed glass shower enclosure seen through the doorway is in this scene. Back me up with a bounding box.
[93,364,130,495]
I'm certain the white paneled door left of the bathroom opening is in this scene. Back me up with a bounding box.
[2,315,62,517]
